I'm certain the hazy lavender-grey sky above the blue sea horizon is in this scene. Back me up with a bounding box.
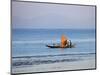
[12,1,95,29]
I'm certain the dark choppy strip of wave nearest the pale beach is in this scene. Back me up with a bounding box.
[12,59,80,66]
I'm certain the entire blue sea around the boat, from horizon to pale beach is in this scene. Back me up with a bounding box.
[12,29,95,66]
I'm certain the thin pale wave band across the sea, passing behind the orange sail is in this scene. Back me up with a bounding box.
[12,39,95,44]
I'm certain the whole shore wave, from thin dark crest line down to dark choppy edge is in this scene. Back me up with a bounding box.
[12,53,95,67]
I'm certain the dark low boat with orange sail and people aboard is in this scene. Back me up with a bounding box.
[46,35,75,48]
